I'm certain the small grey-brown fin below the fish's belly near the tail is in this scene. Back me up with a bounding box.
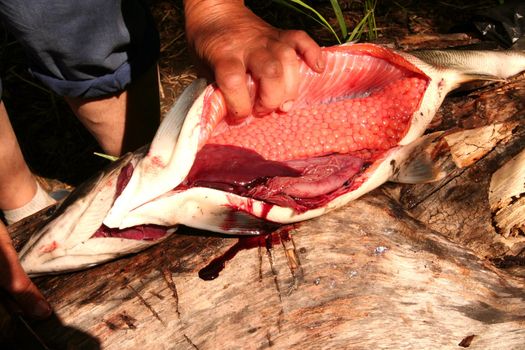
[389,152,446,184]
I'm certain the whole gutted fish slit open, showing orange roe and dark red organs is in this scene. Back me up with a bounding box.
[21,44,525,274]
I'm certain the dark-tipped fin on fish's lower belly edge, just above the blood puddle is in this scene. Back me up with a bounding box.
[181,208,280,236]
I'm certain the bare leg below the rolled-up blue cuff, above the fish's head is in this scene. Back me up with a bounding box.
[66,66,160,156]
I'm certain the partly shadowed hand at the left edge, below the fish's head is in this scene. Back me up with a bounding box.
[0,221,51,319]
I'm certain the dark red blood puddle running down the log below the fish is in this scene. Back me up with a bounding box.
[199,225,294,281]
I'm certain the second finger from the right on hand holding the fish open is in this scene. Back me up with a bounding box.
[268,41,300,112]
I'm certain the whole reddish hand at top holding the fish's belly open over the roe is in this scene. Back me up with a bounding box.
[184,0,325,118]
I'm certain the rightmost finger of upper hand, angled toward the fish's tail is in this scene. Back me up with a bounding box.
[280,30,326,73]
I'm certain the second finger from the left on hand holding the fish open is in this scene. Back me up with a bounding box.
[246,48,285,115]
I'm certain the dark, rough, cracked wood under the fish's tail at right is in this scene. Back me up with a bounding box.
[398,69,525,262]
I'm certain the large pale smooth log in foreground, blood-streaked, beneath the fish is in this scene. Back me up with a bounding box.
[1,191,525,349]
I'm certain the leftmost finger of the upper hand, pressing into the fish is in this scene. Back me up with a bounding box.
[214,58,252,118]
